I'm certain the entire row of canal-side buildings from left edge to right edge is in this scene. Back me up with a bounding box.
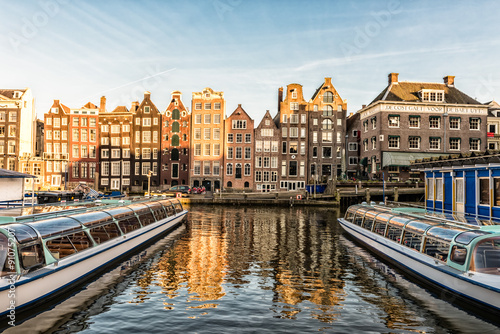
[0,73,500,193]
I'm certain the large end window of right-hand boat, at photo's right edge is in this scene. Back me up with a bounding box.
[472,237,500,275]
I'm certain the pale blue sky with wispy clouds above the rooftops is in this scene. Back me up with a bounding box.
[0,0,500,121]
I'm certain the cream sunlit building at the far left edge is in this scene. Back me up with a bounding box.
[0,88,35,171]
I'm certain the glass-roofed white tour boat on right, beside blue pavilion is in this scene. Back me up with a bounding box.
[338,204,500,318]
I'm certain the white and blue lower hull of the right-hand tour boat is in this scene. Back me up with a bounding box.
[338,218,500,318]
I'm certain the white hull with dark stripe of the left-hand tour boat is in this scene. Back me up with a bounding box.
[0,211,187,316]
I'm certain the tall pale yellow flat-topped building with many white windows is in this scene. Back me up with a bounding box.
[190,88,226,191]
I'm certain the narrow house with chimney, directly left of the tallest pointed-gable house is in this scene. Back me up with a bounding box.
[275,84,309,190]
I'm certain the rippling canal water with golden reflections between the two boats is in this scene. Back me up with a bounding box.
[7,206,500,334]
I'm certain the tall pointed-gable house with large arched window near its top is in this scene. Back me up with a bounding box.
[308,78,347,182]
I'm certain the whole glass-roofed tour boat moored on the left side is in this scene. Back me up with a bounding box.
[0,199,187,320]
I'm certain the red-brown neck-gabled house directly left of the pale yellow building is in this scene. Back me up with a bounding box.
[161,91,191,188]
